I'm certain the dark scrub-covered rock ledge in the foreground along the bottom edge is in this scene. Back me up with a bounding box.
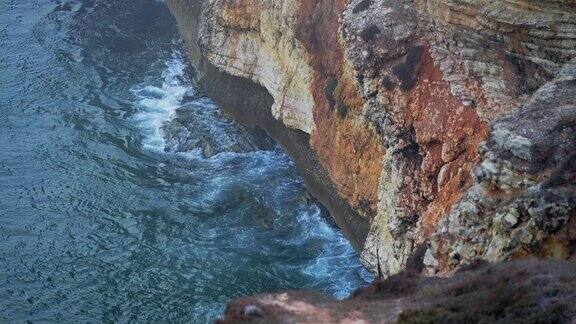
[217,261,576,324]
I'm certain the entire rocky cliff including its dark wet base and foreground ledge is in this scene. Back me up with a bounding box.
[167,0,576,323]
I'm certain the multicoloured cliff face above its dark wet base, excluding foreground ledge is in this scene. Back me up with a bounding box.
[168,0,576,276]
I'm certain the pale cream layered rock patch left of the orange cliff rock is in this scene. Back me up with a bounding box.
[199,0,314,133]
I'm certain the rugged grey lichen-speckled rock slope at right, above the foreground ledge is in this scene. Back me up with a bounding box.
[425,63,576,273]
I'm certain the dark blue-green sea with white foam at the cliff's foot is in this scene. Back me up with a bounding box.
[0,0,364,322]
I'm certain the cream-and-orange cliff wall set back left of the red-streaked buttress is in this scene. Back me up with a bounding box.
[199,0,382,223]
